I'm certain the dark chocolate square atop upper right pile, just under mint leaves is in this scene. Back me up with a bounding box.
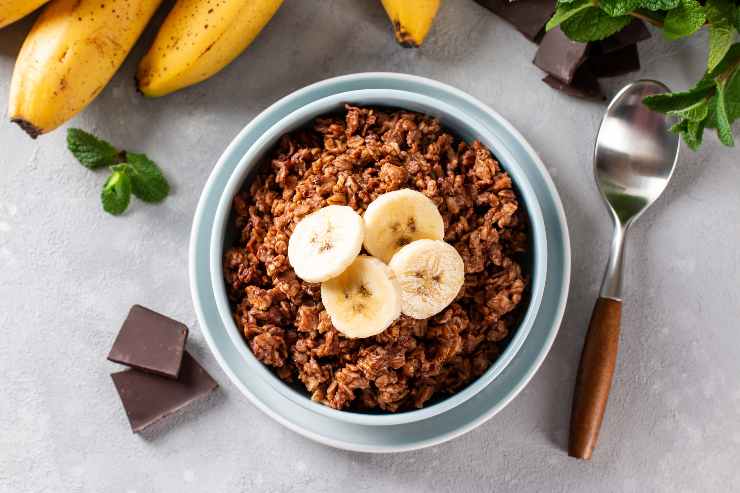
[534,27,588,84]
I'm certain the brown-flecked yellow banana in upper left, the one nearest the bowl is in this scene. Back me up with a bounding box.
[136,0,283,97]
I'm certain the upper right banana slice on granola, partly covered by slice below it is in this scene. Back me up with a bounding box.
[362,188,445,263]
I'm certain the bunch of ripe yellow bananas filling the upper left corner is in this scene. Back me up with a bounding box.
[5,0,282,138]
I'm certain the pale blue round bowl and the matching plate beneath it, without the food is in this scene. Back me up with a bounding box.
[190,73,570,452]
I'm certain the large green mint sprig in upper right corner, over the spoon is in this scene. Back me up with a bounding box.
[546,0,740,150]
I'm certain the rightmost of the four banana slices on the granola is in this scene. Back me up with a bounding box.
[390,240,465,320]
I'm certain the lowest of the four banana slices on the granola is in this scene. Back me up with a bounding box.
[321,255,401,338]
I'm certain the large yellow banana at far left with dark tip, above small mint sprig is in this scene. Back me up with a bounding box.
[8,0,161,138]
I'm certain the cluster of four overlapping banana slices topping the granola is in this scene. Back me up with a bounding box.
[288,189,465,338]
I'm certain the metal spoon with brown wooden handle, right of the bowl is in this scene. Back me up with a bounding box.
[568,80,679,459]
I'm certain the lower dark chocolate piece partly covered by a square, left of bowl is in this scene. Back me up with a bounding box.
[111,352,218,433]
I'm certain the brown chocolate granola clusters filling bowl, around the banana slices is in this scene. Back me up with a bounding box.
[224,106,528,412]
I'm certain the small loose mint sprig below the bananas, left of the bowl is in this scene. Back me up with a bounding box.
[67,128,170,216]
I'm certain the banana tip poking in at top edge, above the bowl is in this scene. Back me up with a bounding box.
[381,0,440,48]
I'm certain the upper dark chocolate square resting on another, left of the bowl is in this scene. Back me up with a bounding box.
[108,305,188,378]
